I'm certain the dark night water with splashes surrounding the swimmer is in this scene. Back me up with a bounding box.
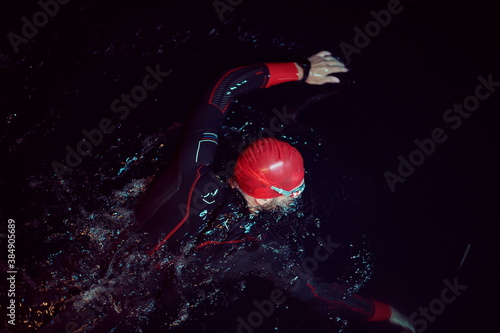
[0,0,500,332]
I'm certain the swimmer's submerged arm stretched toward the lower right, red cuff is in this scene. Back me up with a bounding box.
[188,232,416,333]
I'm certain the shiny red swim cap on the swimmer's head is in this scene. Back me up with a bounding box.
[234,138,304,199]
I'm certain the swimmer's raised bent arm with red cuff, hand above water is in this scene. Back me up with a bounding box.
[181,51,347,174]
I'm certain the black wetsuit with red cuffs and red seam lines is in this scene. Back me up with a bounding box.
[136,63,390,321]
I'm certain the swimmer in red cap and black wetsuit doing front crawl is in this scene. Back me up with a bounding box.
[136,51,415,332]
